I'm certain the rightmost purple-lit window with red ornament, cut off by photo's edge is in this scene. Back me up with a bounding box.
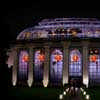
[89,48,100,84]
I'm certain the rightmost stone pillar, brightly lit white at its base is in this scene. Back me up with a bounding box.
[83,41,89,87]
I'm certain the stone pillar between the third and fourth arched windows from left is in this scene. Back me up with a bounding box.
[63,42,69,85]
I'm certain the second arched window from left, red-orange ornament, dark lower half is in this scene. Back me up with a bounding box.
[34,49,45,82]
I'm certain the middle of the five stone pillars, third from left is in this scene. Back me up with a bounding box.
[43,46,50,87]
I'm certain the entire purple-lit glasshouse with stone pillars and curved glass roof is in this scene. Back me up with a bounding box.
[7,18,100,87]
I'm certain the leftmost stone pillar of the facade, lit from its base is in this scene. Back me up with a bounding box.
[12,48,18,86]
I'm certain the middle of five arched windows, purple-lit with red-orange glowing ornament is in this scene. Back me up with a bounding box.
[50,49,63,83]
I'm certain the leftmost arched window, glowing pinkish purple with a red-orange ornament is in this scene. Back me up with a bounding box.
[18,50,29,81]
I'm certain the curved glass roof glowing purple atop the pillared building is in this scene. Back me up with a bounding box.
[17,18,100,40]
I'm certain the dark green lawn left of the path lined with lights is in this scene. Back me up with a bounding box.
[8,87,63,100]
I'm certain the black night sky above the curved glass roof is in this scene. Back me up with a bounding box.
[1,1,100,47]
